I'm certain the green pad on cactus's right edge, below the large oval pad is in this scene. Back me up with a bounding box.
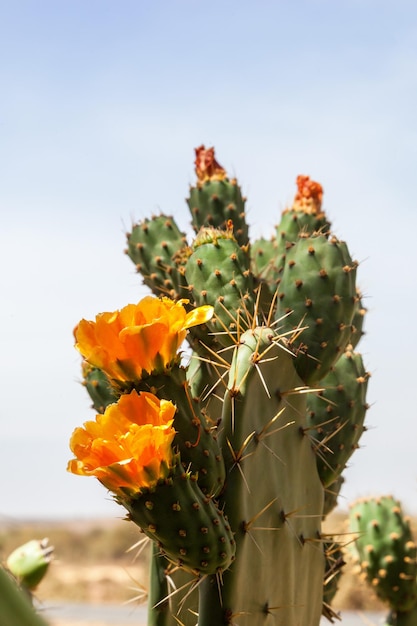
[307,350,369,487]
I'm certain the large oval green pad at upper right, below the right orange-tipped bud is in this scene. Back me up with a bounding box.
[276,235,357,385]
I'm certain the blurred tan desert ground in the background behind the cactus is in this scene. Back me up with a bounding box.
[0,512,384,626]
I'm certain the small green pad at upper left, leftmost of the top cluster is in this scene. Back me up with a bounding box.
[126,215,186,299]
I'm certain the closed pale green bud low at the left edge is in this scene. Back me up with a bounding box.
[6,537,54,590]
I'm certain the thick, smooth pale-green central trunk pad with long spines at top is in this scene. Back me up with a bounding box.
[199,328,324,626]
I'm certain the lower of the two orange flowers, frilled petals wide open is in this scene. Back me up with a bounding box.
[67,391,176,496]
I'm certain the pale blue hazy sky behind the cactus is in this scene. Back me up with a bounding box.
[0,0,417,519]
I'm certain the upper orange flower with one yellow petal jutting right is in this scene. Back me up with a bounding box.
[74,296,213,382]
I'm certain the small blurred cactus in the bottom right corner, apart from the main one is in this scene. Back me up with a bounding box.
[349,496,417,626]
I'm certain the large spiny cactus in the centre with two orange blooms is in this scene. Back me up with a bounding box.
[68,146,368,626]
